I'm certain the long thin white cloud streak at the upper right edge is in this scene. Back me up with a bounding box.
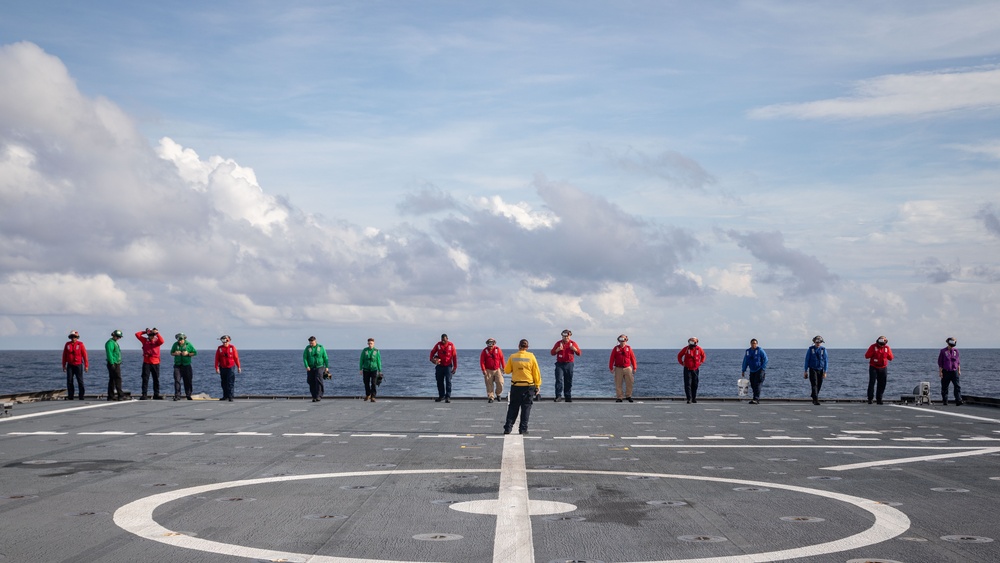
[750,67,1000,119]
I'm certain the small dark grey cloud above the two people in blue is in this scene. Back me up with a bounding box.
[726,230,837,296]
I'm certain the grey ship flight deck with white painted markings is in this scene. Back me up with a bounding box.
[0,399,1000,563]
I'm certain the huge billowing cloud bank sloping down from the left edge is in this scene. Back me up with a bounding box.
[0,43,716,344]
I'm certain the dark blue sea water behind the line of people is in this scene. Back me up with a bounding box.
[0,348,1000,399]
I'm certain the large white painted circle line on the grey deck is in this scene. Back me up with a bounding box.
[114,469,910,563]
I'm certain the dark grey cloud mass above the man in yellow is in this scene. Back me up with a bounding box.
[437,176,700,300]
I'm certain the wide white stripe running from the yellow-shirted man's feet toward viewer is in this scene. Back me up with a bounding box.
[493,434,535,563]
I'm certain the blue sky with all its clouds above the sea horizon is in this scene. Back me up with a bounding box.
[0,0,1000,351]
